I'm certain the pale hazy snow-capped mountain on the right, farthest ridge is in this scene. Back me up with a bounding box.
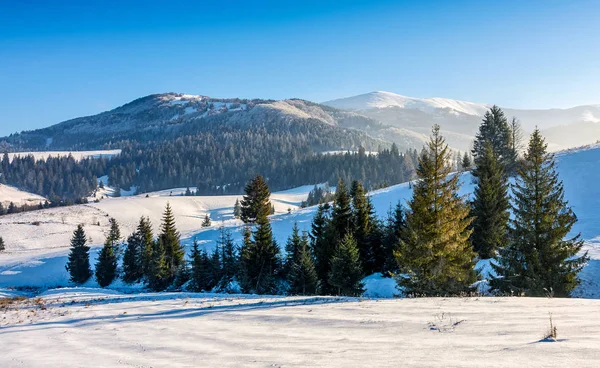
[323,91,600,151]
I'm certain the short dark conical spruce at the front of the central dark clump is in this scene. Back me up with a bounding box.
[329,234,364,296]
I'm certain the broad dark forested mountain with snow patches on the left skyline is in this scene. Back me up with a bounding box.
[0,93,389,151]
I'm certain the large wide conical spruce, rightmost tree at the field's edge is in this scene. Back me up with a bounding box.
[492,129,589,296]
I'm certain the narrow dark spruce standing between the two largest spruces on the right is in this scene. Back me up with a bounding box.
[471,142,510,259]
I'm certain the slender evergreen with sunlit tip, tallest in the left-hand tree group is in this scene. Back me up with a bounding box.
[159,203,184,284]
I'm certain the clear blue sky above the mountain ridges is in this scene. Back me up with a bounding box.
[0,0,600,135]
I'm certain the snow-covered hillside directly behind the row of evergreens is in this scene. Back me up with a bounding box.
[0,145,600,297]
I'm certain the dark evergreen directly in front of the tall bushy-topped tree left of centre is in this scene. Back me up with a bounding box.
[241,207,279,294]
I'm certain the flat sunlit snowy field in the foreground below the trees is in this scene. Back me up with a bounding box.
[0,289,600,368]
